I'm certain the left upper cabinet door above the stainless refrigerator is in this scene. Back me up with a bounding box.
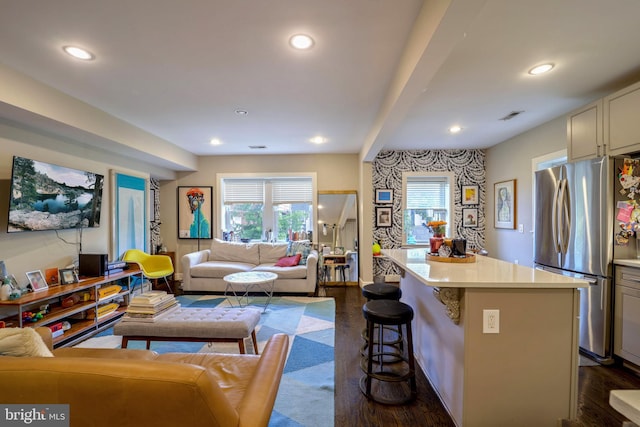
[567,99,605,160]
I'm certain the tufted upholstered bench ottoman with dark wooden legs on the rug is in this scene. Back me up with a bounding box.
[113,307,260,354]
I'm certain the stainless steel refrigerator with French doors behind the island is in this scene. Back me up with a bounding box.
[534,157,615,363]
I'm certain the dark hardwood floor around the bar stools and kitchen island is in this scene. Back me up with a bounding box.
[324,286,640,427]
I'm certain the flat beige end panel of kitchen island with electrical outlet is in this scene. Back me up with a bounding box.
[463,289,580,427]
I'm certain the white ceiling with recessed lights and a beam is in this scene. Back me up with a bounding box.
[0,0,640,166]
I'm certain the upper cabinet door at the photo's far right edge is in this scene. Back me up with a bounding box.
[604,83,640,156]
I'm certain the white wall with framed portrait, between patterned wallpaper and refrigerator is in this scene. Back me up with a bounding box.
[485,117,567,266]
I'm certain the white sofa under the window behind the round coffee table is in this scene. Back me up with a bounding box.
[181,239,318,295]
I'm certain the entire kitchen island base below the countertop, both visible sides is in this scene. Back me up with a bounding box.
[400,271,579,426]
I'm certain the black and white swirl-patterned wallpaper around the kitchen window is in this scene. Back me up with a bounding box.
[372,150,486,276]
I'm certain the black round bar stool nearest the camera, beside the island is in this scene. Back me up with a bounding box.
[360,300,417,405]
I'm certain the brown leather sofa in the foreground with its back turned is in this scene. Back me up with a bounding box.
[0,328,289,427]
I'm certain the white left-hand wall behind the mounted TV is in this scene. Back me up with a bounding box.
[0,123,158,283]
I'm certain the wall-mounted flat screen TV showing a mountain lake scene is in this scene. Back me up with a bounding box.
[7,156,104,233]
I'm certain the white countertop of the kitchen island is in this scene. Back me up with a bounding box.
[382,248,588,289]
